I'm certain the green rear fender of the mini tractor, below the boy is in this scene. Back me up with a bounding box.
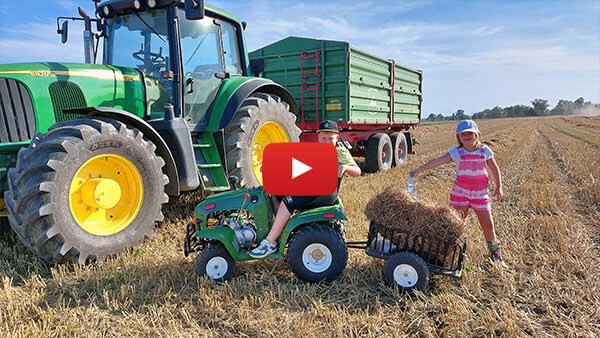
[279,203,348,255]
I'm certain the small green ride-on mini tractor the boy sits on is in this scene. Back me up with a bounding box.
[184,180,348,283]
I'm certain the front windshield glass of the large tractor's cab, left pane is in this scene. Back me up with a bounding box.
[105,9,173,117]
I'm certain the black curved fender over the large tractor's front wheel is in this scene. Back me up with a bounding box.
[63,107,180,196]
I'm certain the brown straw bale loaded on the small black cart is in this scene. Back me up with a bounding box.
[364,185,467,263]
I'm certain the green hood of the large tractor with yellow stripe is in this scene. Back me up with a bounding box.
[0,62,146,135]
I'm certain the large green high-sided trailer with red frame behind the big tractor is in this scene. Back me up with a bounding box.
[249,37,423,172]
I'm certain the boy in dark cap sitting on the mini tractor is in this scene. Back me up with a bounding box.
[249,121,361,258]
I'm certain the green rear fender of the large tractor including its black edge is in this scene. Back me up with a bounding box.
[205,77,298,132]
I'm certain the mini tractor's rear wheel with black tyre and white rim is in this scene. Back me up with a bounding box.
[287,225,348,283]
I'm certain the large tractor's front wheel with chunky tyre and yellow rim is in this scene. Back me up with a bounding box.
[4,118,169,264]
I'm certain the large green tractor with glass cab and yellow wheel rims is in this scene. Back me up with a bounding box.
[0,0,300,263]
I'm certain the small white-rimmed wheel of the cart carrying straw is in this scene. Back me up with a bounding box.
[384,251,429,292]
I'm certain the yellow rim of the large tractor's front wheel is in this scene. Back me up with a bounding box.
[69,154,144,236]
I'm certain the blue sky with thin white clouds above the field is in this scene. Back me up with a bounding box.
[0,0,600,117]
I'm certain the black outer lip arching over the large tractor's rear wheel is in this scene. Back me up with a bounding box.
[219,78,298,129]
